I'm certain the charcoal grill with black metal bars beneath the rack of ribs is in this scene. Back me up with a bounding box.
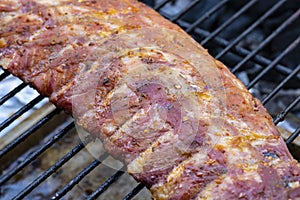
[0,0,300,199]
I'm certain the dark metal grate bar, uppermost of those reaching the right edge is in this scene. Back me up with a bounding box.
[232,9,300,73]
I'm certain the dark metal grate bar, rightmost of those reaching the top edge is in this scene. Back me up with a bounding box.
[215,0,286,59]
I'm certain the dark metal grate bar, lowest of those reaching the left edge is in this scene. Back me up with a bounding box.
[0,122,74,185]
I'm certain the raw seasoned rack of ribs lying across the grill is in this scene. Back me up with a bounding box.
[0,0,300,199]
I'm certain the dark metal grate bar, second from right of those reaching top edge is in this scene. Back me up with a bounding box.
[201,0,257,45]
